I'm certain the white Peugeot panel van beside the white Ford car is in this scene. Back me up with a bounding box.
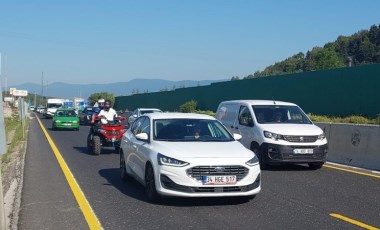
[216,100,328,169]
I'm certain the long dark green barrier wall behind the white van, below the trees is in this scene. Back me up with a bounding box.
[115,64,380,117]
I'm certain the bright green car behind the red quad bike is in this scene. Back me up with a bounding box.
[52,109,79,130]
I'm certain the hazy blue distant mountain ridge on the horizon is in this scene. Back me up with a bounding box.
[11,79,223,99]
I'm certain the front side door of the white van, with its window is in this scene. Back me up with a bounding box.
[236,105,253,148]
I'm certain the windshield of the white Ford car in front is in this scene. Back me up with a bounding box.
[153,119,234,142]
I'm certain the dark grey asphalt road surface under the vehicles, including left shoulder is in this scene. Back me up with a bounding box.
[19,113,380,229]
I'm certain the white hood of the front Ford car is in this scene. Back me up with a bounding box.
[154,141,254,159]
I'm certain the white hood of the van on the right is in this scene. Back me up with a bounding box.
[260,124,323,136]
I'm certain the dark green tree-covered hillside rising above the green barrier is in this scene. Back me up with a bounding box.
[235,24,380,80]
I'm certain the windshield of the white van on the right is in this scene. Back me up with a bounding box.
[252,105,312,124]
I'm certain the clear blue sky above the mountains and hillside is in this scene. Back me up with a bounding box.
[0,0,380,86]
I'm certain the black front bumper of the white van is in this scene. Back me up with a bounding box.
[260,143,328,164]
